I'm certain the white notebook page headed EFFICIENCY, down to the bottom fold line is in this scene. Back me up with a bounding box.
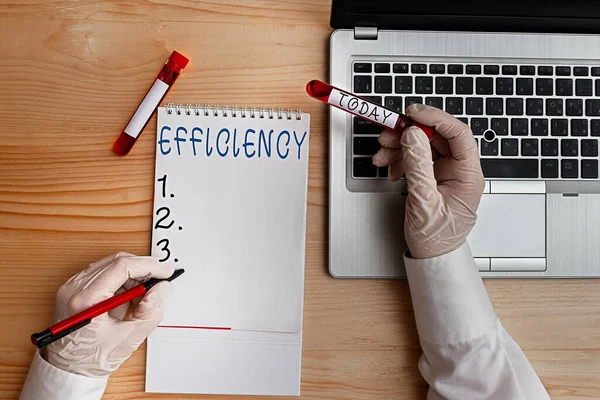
[152,107,310,332]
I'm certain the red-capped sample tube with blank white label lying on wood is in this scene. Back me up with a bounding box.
[113,51,189,156]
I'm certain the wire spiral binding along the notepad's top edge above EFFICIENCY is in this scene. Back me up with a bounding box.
[165,103,302,120]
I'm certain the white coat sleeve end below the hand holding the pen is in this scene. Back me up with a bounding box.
[19,351,108,400]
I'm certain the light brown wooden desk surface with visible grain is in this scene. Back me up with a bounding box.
[0,0,600,399]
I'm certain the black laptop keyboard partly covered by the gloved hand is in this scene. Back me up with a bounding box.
[352,61,600,180]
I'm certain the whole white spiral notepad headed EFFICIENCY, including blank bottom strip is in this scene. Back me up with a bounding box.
[146,105,310,395]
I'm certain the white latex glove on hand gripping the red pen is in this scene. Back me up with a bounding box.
[42,253,173,377]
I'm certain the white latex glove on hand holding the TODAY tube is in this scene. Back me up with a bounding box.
[373,104,484,258]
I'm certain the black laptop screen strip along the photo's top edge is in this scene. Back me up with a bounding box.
[331,0,600,33]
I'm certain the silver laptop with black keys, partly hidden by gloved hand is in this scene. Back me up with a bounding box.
[329,0,600,278]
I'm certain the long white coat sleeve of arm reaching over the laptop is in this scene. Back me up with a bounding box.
[404,243,550,400]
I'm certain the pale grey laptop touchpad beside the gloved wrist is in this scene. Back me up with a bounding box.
[467,194,546,257]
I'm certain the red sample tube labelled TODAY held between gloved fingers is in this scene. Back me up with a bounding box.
[306,80,435,139]
